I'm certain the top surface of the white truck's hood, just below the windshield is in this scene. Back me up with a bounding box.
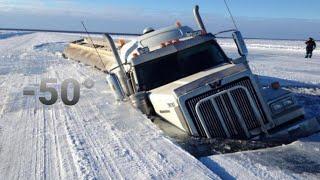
[150,64,248,97]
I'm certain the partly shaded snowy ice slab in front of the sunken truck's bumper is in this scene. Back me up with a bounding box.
[200,134,320,179]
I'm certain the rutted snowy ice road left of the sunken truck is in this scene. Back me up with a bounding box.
[0,33,218,179]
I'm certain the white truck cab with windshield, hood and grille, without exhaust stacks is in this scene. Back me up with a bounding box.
[115,21,318,139]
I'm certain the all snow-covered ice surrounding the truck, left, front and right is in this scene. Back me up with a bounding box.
[0,32,320,179]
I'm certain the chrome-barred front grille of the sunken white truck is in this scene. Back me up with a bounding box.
[186,78,268,139]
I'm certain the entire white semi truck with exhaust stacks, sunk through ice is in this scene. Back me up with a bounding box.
[65,6,320,139]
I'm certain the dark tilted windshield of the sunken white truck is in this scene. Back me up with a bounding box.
[135,40,228,91]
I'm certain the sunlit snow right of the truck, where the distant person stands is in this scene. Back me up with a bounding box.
[219,39,320,87]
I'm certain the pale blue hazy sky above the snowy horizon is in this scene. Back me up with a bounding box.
[0,0,320,39]
